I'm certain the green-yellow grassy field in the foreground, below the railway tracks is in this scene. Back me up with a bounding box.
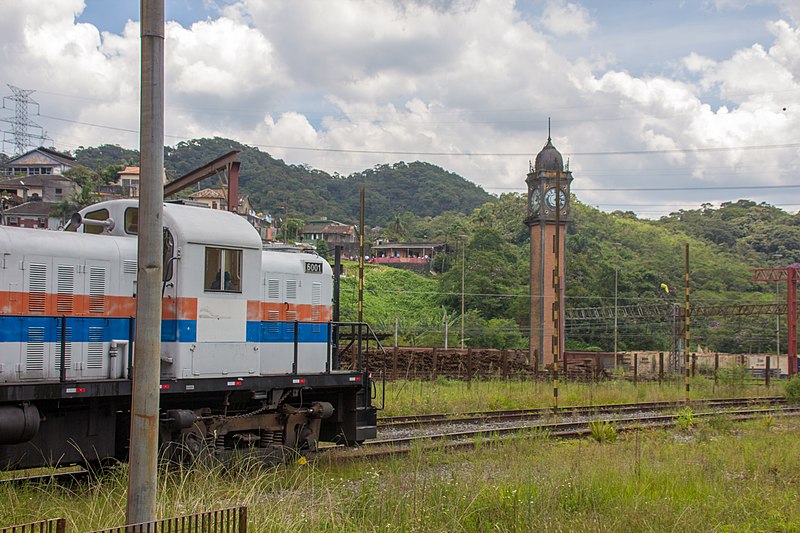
[0,376,800,532]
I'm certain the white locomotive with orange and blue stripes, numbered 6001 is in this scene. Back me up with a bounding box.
[0,200,376,469]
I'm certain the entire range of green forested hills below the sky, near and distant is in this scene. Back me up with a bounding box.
[70,138,800,352]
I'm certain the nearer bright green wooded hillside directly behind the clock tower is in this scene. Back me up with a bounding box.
[334,194,799,353]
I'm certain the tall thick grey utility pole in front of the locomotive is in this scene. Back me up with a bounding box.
[126,0,164,524]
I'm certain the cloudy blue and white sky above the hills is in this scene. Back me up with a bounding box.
[0,0,800,218]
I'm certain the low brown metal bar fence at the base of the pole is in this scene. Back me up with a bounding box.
[0,507,247,533]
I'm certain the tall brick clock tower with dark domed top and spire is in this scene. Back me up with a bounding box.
[525,128,572,368]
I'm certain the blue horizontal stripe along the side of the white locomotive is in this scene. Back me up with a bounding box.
[0,316,329,343]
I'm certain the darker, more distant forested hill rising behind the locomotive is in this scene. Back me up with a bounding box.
[75,137,493,226]
